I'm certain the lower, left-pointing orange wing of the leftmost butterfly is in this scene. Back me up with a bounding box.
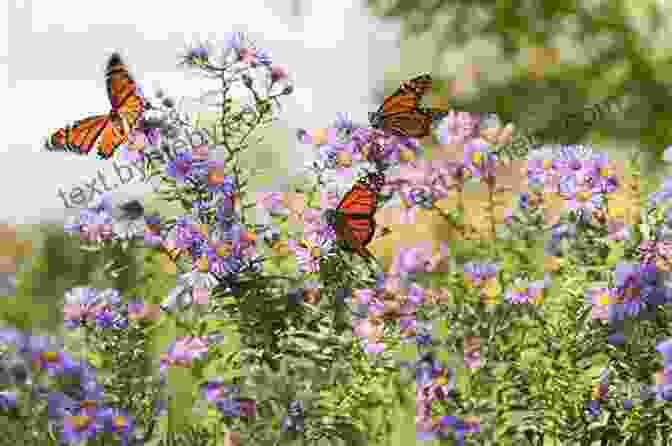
[46,115,111,155]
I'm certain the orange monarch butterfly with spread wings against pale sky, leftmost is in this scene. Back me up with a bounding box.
[45,53,145,159]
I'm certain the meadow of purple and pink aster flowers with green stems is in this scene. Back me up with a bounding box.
[0,33,672,446]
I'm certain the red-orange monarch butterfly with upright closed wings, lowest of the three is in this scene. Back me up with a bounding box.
[327,172,385,260]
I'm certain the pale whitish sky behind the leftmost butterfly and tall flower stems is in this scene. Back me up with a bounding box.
[0,0,404,224]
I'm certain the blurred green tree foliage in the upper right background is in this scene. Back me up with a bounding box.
[368,0,672,164]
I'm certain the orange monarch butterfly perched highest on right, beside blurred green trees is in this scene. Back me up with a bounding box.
[369,74,449,138]
